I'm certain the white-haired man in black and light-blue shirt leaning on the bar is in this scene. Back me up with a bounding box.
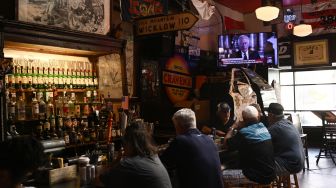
[223,106,275,184]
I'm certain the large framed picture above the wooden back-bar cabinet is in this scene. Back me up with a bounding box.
[18,0,110,35]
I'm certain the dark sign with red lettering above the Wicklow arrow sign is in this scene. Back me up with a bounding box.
[120,0,168,21]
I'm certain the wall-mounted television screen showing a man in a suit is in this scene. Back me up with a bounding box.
[218,32,278,66]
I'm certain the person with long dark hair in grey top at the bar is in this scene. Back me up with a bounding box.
[100,122,172,188]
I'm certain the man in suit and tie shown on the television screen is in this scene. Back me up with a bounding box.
[235,35,260,60]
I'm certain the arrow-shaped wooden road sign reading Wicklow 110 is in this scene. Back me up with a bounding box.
[136,12,198,35]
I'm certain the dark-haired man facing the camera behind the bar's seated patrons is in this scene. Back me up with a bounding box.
[202,102,233,136]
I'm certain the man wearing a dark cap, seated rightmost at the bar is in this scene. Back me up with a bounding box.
[268,103,304,176]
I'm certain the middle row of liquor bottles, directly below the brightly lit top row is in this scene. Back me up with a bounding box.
[6,90,100,121]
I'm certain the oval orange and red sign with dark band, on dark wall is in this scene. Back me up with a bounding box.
[162,55,192,104]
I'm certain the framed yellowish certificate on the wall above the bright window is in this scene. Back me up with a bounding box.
[294,39,330,67]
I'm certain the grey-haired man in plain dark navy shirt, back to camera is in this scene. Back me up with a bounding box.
[161,108,223,188]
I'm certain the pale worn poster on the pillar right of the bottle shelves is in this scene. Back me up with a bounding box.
[98,54,123,99]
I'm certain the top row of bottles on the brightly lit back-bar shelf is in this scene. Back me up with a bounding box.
[5,59,98,89]
